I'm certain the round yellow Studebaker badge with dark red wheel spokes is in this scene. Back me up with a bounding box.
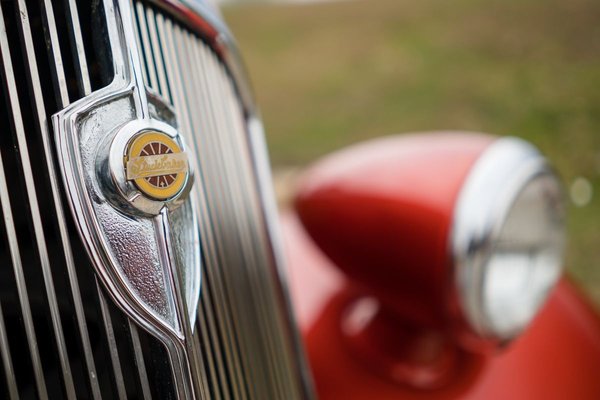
[124,131,189,201]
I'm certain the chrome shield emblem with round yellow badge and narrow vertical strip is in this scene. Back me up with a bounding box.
[53,0,201,399]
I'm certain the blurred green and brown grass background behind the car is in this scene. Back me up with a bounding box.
[224,0,600,304]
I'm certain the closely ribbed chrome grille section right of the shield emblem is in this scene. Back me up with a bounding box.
[135,2,303,399]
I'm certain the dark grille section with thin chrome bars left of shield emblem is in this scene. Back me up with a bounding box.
[0,0,171,399]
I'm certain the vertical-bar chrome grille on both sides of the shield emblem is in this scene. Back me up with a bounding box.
[0,0,307,399]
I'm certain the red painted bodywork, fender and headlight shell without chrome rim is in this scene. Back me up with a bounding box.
[282,135,600,400]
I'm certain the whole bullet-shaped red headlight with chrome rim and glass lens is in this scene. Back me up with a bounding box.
[295,132,565,353]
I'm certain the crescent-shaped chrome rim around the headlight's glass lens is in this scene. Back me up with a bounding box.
[450,137,560,342]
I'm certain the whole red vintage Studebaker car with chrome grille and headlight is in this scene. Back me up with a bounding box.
[0,0,600,400]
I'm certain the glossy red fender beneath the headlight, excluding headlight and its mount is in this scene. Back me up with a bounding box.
[283,214,600,400]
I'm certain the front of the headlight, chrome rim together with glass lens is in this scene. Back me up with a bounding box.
[453,139,565,341]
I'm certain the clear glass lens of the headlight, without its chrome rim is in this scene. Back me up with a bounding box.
[482,174,565,339]
